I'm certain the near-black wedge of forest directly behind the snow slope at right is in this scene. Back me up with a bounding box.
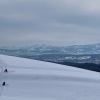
[55,62,100,72]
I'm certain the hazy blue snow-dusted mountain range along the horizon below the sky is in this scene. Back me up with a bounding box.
[0,43,100,54]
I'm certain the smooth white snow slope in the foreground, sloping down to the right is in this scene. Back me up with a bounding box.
[0,55,100,100]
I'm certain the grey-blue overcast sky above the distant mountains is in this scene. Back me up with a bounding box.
[0,0,100,46]
